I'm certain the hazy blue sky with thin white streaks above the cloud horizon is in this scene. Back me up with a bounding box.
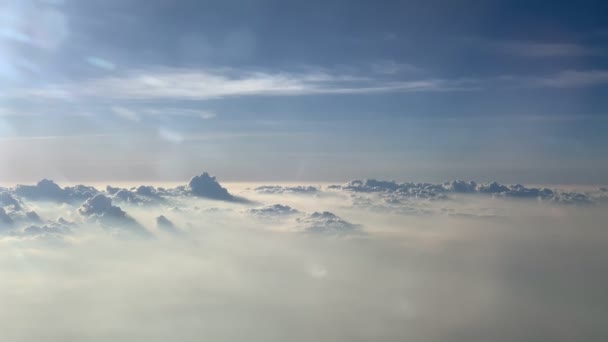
[0,0,608,184]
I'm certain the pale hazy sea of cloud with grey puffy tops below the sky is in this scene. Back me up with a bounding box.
[0,173,608,342]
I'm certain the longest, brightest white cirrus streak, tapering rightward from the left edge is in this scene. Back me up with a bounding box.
[4,69,474,100]
